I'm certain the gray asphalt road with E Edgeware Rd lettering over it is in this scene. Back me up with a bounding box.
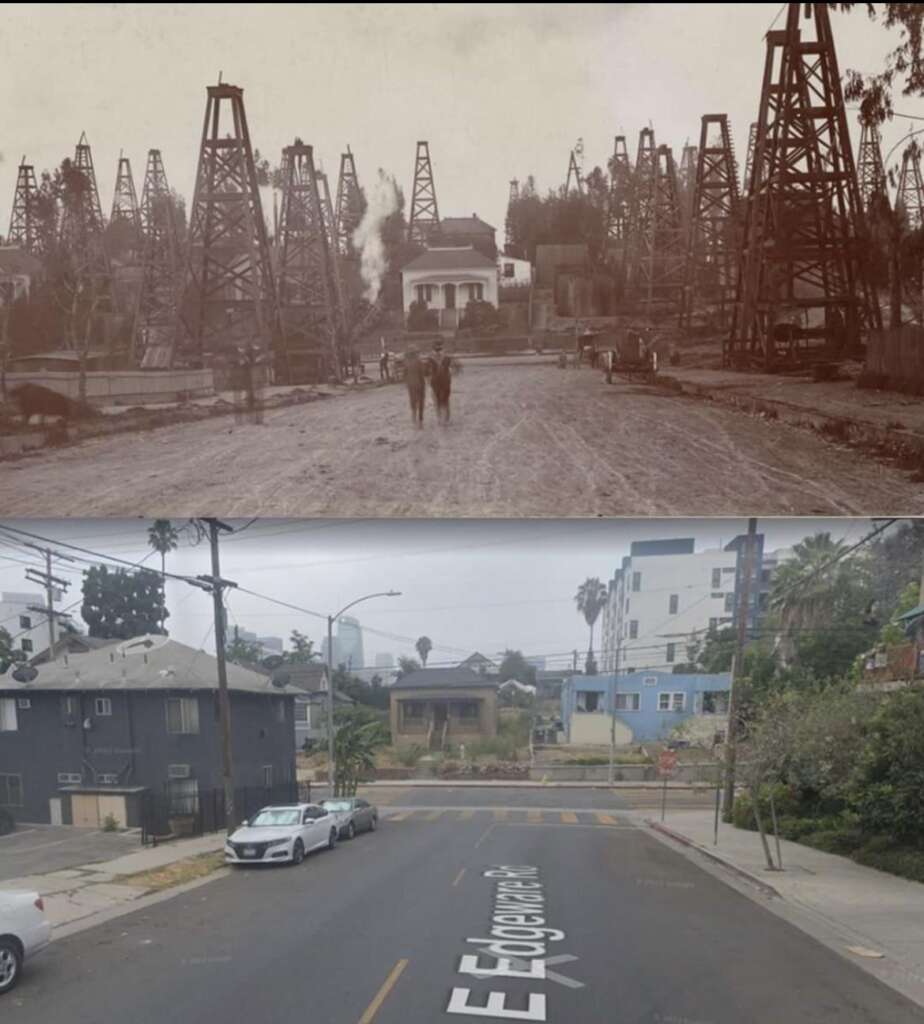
[2,791,920,1024]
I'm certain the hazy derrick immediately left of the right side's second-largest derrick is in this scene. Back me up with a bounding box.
[636,145,686,306]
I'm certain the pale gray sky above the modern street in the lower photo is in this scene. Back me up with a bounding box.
[0,518,870,666]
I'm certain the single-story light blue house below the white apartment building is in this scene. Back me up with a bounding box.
[561,672,731,745]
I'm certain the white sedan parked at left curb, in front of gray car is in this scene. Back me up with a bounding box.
[224,804,340,864]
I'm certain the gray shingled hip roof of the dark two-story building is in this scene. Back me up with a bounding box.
[0,636,303,695]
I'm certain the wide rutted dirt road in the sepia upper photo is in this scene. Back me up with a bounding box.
[0,360,924,517]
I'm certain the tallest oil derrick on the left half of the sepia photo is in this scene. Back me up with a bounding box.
[176,82,276,365]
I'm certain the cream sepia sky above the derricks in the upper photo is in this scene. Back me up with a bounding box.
[0,3,924,243]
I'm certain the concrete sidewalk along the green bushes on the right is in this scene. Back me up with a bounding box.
[647,809,924,1006]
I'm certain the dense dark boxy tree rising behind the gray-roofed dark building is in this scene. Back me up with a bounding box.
[80,565,170,640]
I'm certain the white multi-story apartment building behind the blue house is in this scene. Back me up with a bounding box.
[600,535,763,674]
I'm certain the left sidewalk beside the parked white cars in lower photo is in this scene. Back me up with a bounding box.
[0,833,224,933]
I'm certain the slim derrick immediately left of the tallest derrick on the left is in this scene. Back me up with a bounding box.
[134,150,179,368]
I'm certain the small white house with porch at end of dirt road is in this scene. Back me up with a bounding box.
[402,246,498,328]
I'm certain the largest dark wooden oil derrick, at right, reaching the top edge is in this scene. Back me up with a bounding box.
[724,3,881,369]
